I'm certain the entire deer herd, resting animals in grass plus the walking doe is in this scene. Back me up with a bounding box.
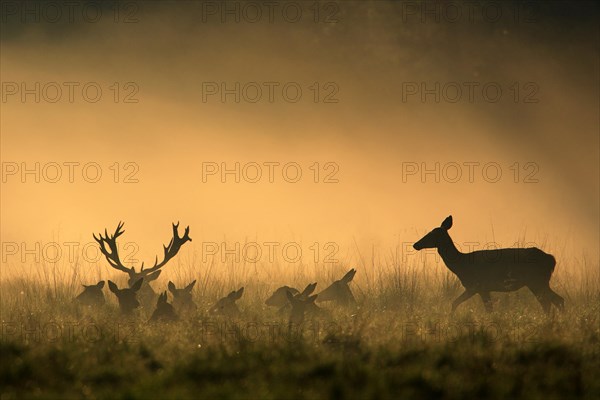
[75,216,564,325]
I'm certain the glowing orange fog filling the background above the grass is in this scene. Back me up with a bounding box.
[0,1,600,268]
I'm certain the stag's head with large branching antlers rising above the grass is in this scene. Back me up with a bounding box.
[93,222,192,308]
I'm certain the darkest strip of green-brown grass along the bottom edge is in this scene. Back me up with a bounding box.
[0,328,600,399]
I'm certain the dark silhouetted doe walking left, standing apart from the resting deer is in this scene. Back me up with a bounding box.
[413,216,565,313]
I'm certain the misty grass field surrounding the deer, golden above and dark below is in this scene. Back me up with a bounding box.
[0,247,600,400]
